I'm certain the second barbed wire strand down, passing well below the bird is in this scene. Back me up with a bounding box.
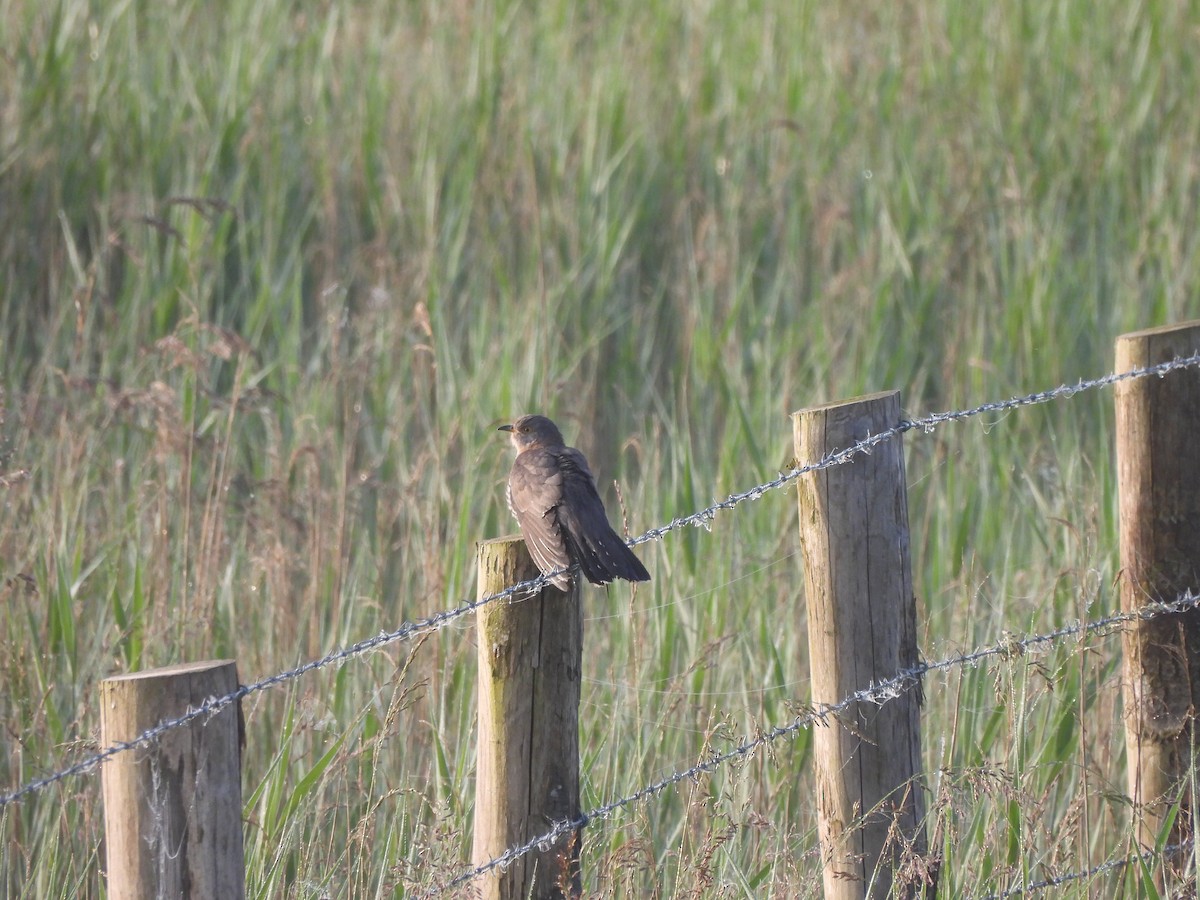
[418,590,1200,899]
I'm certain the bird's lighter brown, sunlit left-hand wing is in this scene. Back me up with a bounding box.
[509,450,571,590]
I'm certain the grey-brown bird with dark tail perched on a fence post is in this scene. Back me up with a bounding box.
[499,415,650,590]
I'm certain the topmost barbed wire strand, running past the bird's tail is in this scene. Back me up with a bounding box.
[0,353,1200,810]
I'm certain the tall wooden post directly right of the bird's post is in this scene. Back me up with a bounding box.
[792,391,935,900]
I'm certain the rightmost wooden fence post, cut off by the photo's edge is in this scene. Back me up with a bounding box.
[1116,322,1200,864]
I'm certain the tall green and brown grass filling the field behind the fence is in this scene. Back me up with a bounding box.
[0,0,1200,898]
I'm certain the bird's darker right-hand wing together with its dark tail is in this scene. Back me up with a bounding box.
[556,448,650,584]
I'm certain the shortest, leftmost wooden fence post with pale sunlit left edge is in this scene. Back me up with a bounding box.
[100,660,246,900]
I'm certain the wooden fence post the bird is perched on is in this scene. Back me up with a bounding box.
[472,538,583,900]
